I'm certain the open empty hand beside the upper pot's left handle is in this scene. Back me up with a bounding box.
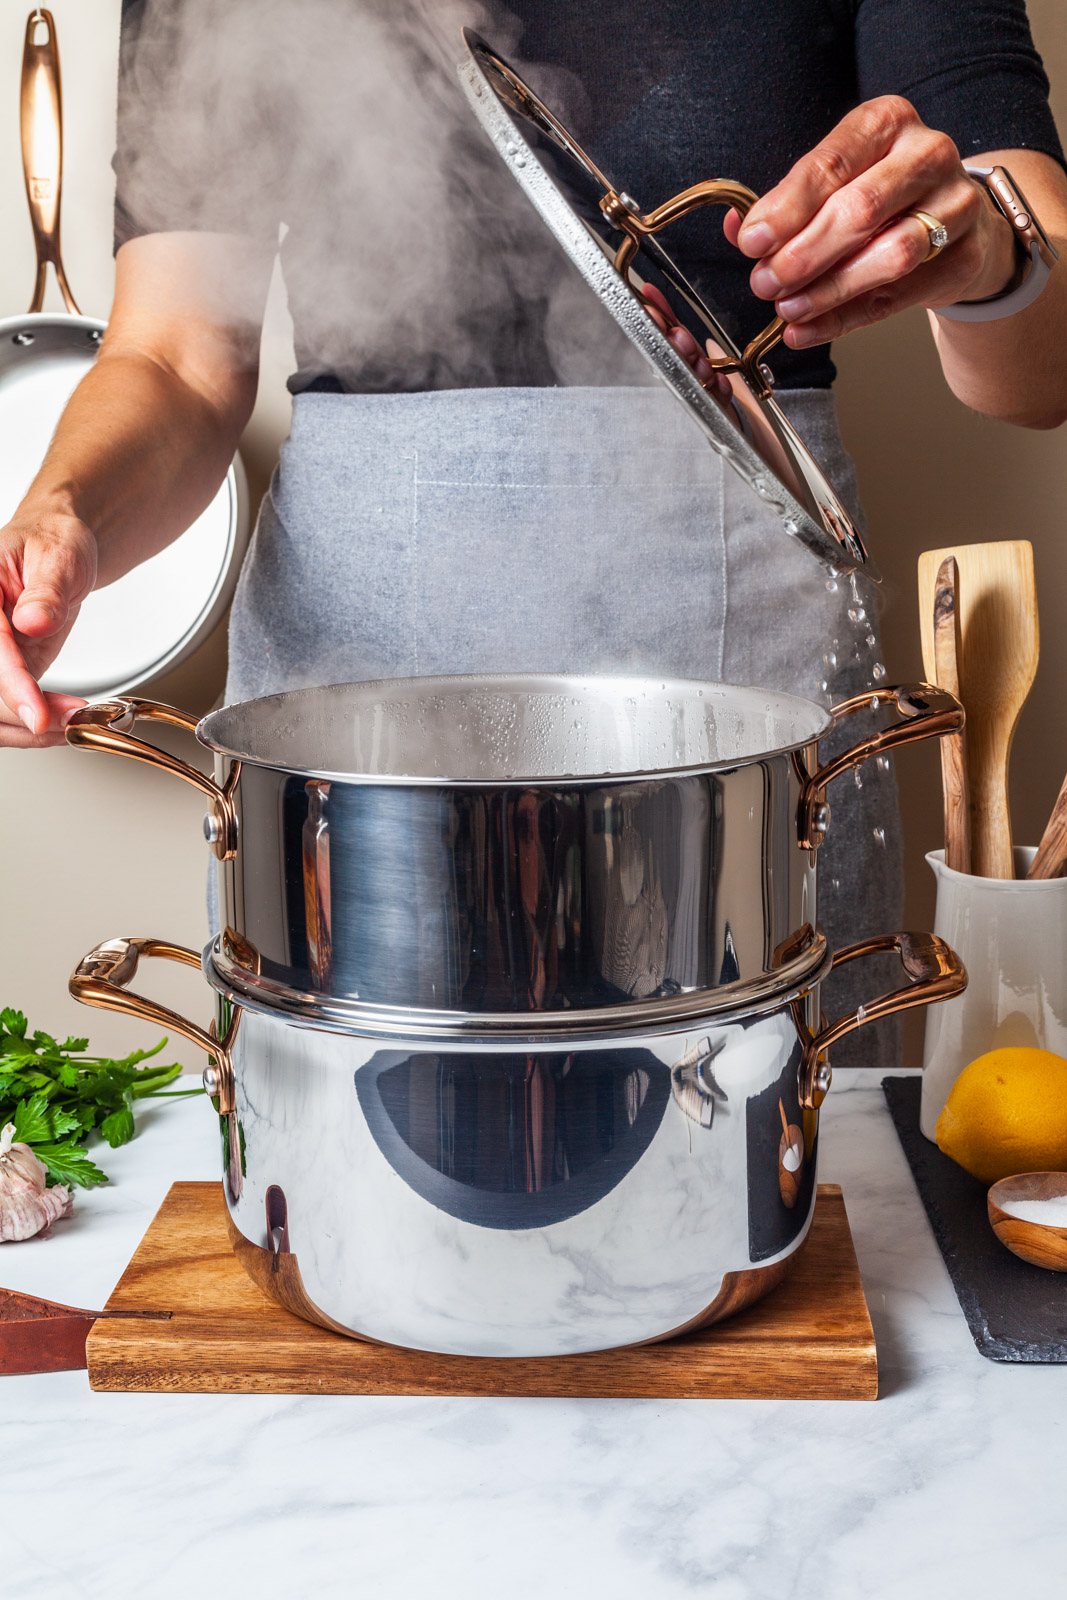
[0,510,96,747]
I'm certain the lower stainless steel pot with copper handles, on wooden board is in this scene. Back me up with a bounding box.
[70,934,966,1357]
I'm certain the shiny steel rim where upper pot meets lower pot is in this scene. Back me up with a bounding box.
[202,930,833,1048]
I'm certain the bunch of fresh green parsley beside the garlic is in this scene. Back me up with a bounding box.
[0,1006,195,1189]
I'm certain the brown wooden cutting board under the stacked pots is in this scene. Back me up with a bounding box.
[86,1184,878,1400]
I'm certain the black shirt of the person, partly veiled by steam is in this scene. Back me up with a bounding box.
[115,0,1064,392]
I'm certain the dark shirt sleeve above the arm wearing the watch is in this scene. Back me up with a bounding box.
[856,0,1064,165]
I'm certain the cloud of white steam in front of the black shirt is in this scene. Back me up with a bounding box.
[117,0,646,390]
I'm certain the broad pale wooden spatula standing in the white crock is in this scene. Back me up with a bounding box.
[918,539,1038,878]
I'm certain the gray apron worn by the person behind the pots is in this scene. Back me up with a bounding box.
[226,387,902,1069]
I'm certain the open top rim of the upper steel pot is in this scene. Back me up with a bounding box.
[195,672,833,790]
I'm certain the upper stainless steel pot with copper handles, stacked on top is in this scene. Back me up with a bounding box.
[67,675,963,1027]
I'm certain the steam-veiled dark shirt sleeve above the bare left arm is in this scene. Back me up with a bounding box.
[112,0,278,250]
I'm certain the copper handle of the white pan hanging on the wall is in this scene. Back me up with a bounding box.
[21,6,80,317]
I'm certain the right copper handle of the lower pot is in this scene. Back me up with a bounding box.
[798,933,966,1110]
